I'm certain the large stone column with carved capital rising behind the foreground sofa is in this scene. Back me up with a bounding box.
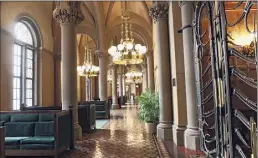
[53,1,84,140]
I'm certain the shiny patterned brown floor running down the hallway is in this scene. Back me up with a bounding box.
[62,106,159,158]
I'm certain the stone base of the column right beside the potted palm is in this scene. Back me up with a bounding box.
[157,123,173,140]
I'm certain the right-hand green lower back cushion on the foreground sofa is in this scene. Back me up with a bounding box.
[35,121,54,136]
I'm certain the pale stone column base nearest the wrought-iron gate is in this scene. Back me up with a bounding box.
[184,128,200,150]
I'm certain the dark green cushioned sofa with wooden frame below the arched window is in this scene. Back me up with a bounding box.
[0,111,73,157]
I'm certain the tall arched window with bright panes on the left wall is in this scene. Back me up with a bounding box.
[13,20,39,110]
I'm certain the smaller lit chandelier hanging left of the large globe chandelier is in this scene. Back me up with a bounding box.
[77,46,99,77]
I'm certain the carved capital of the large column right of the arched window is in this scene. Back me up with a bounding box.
[53,1,84,25]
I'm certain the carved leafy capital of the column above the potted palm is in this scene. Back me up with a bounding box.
[149,1,169,22]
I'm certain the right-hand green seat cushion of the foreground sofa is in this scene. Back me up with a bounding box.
[21,136,55,144]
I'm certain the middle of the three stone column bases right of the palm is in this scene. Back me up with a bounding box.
[172,125,186,146]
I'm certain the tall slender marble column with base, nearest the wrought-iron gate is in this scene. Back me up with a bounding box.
[179,1,200,150]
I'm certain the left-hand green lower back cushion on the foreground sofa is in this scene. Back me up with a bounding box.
[5,122,35,137]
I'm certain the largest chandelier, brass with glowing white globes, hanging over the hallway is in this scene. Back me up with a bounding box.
[108,2,147,65]
